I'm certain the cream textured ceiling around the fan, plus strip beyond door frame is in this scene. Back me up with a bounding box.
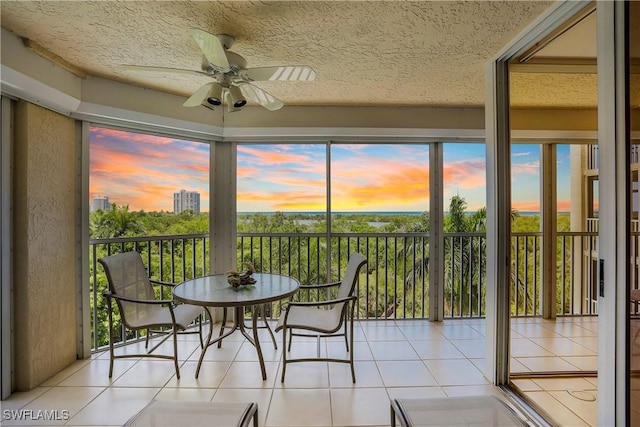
[0,0,595,107]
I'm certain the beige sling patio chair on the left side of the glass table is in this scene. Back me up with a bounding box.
[98,251,212,378]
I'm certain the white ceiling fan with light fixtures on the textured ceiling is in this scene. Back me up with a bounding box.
[124,29,316,112]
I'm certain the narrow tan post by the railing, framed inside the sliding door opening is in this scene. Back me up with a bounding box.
[540,144,558,319]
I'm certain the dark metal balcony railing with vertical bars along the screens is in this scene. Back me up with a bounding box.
[90,232,597,349]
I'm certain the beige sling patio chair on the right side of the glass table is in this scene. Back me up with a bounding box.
[275,252,367,383]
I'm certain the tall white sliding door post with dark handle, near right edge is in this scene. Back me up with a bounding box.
[597,1,630,426]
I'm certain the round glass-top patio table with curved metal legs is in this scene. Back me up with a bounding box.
[173,273,300,380]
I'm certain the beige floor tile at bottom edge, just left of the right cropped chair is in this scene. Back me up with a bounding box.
[331,388,390,426]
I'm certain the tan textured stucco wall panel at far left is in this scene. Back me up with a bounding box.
[14,101,76,391]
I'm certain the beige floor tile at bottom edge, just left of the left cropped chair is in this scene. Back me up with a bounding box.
[67,387,160,426]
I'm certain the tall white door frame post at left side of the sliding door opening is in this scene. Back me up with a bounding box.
[485,61,511,385]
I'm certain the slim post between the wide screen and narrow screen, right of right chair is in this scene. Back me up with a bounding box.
[429,142,444,321]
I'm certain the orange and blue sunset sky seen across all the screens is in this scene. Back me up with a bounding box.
[89,127,570,212]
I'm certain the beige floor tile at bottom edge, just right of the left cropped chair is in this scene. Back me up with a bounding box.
[265,389,332,427]
